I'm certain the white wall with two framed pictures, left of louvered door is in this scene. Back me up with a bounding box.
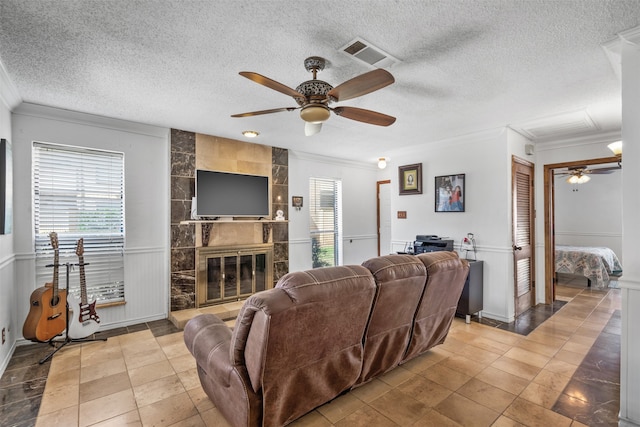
[377,128,525,321]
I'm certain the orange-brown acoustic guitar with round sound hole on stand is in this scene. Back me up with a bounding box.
[22,231,67,342]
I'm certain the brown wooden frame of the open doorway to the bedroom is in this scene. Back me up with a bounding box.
[544,156,620,304]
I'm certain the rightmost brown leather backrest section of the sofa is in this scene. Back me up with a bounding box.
[403,251,469,362]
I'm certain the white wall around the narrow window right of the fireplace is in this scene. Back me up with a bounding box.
[289,150,378,271]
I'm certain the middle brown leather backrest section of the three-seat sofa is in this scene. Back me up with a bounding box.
[356,255,427,385]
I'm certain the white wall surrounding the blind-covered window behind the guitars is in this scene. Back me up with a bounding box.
[10,104,170,335]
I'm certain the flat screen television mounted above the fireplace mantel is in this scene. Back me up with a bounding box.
[195,169,271,218]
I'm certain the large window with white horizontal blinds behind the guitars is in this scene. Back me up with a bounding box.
[33,142,124,304]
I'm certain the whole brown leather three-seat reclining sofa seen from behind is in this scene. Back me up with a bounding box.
[184,252,469,427]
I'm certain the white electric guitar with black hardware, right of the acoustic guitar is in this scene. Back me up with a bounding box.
[67,239,100,338]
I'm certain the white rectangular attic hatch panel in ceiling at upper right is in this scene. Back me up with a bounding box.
[516,111,599,140]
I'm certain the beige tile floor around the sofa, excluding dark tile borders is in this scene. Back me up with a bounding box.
[36,287,620,427]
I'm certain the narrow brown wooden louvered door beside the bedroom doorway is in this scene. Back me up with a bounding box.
[512,157,535,317]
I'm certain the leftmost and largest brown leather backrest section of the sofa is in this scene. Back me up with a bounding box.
[232,266,376,426]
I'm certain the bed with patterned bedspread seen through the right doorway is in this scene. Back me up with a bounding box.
[555,246,622,288]
